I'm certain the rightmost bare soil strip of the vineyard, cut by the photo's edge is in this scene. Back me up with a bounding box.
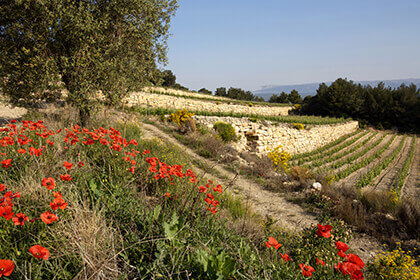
[401,138,420,201]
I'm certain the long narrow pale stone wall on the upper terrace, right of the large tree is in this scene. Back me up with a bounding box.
[124,92,292,116]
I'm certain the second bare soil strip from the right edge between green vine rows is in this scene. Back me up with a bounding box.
[365,137,412,194]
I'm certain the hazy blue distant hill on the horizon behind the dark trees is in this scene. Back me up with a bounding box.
[253,79,420,100]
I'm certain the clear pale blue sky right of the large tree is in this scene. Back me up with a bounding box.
[165,0,420,90]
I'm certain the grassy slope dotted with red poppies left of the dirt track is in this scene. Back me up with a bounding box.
[0,106,400,279]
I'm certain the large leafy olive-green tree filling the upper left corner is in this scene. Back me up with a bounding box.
[0,0,177,122]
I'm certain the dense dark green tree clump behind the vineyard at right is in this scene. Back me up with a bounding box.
[295,78,420,132]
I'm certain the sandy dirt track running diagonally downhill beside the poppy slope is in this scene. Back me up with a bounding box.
[141,123,382,261]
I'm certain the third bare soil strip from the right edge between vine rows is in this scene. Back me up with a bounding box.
[337,135,402,187]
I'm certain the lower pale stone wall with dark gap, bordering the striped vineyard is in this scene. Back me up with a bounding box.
[194,116,359,155]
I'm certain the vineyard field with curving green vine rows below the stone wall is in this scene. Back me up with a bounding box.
[292,130,420,199]
